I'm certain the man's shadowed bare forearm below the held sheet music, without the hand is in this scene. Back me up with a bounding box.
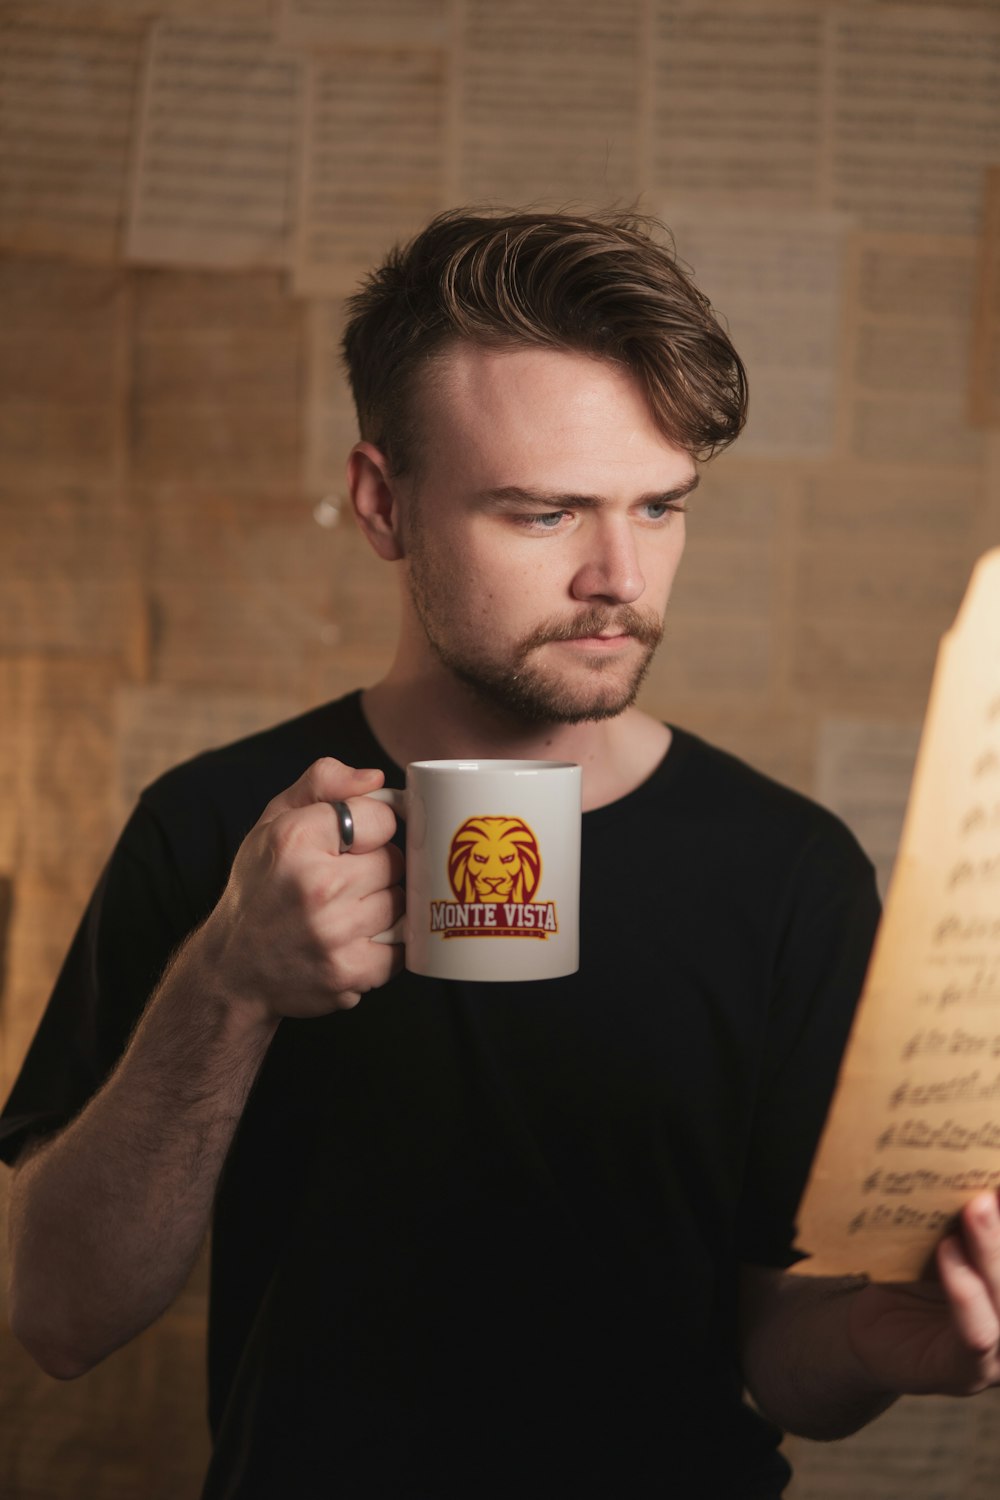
[744,1277,895,1442]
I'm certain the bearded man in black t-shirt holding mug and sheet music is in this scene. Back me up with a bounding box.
[6,213,1000,1500]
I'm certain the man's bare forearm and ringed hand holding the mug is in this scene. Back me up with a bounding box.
[9,761,402,1377]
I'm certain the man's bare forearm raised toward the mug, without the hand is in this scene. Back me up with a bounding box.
[10,935,274,1376]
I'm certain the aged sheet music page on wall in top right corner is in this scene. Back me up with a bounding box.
[828,6,1000,236]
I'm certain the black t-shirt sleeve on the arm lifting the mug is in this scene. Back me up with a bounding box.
[0,803,198,1163]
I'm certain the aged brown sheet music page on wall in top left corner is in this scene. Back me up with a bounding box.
[0,6,141,261]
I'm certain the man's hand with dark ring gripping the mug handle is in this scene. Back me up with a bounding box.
[197,758,403,1022]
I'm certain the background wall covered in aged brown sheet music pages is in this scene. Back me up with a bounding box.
[0,0,1000,1500]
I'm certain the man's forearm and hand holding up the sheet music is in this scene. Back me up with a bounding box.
[741,1194,1000,1439]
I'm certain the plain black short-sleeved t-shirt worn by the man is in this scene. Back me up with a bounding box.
[0,695,877,1500]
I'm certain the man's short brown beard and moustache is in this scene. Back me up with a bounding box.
[409,537,664,725]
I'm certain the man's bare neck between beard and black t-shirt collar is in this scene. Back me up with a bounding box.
[361,659,670,809]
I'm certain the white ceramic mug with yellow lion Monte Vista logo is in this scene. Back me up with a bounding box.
[369,759,580,980]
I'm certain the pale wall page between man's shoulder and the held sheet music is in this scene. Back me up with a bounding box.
[816,719,921,897]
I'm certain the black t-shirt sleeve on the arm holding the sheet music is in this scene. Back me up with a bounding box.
[736,825,880,1266]
